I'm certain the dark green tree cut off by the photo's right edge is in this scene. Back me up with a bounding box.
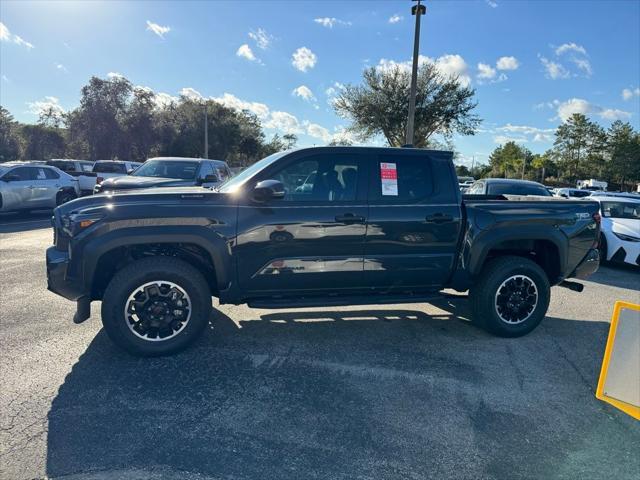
[607,120,640,190]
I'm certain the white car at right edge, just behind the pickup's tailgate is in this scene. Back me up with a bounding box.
[589,195,640,266]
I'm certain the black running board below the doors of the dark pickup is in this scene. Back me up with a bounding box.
[247,292,442,309]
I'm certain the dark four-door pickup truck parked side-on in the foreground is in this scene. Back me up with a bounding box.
[47,147,600,355]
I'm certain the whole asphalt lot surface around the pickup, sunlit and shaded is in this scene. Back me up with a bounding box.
[0,218,640,480]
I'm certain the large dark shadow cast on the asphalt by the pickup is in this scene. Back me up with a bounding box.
[46,304,640,479]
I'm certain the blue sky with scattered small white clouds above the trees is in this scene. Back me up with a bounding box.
[0,0,640,162]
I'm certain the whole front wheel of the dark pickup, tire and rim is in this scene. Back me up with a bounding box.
[102,257,211,357]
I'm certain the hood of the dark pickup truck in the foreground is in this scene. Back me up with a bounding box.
[55,187,233,216]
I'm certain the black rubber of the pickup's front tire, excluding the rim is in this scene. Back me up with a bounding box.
[102,262,211,356]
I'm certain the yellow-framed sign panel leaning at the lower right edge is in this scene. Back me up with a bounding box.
[596,301,640,420]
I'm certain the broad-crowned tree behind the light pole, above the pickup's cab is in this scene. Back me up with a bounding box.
[333,63,481,147]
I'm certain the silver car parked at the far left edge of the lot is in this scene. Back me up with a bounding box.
[0,162,79,212]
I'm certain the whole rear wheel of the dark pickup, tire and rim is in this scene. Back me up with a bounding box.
[469,256,551,337]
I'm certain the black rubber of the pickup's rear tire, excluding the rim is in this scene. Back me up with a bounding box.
[482,261,551,337]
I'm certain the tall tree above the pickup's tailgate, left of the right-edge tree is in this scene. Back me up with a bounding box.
[553,113,606,182]
